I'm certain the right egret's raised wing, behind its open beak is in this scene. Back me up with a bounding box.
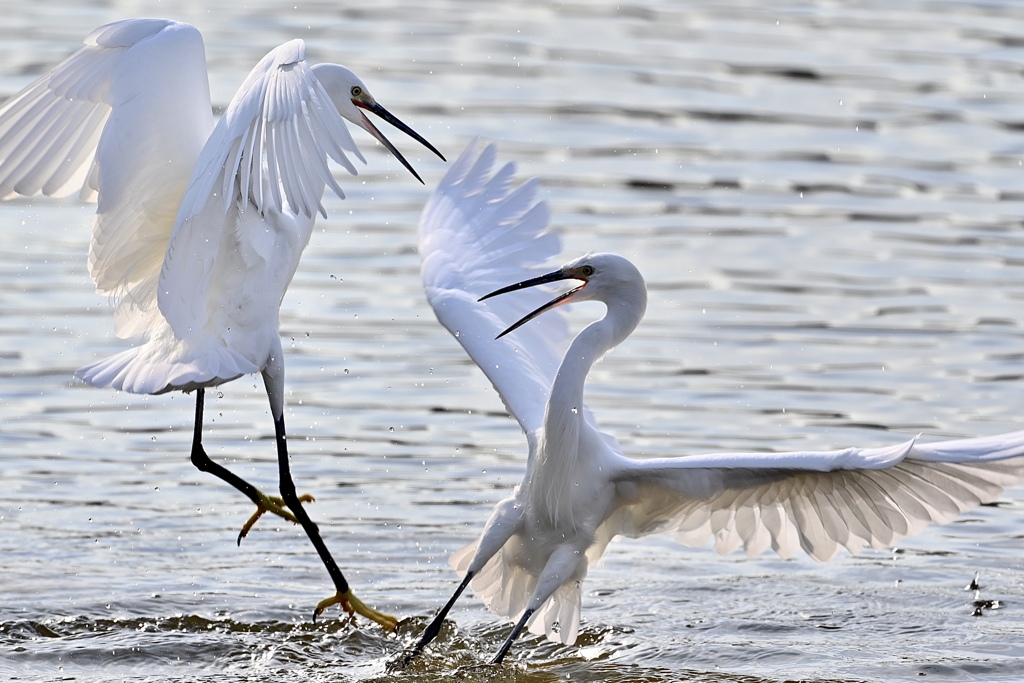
[420,140,571,436]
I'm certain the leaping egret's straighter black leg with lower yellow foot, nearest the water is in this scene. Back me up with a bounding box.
[263,360,398,631]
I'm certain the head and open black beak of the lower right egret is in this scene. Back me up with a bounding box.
[479,253,647,339]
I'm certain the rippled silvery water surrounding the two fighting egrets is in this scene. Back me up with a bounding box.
[0,0,1024,682]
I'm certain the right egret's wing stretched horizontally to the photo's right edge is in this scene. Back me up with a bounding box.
[597,431,1024,562]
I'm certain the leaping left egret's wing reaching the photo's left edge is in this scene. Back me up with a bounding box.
[0,19,213,337]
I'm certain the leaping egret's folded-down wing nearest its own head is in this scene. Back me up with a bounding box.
[159,40,361,338]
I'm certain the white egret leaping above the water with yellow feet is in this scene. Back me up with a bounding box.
[0,18,443,628]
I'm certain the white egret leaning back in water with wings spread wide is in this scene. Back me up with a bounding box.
[403,143,1024,663]
